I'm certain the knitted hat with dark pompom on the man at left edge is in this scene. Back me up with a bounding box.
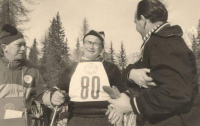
[0,24,24,45]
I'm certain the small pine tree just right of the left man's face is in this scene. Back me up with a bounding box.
[29,39,40,67]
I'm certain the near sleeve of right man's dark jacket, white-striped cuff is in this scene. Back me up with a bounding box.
[131,38,196,117]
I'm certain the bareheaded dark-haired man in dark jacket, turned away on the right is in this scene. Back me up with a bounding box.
[109,0,200,126]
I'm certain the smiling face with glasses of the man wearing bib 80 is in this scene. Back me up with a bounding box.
[83,35,102,60]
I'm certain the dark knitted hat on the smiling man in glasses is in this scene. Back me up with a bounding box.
[83,30,105,48]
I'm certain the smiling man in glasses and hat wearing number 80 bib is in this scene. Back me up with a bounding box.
[51,30,125,126]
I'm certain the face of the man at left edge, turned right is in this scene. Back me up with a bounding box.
[4,38,26,61]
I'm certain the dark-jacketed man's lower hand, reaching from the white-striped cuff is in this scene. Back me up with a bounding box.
[108,93,132,113]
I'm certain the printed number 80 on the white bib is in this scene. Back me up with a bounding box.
[81,76,100,99]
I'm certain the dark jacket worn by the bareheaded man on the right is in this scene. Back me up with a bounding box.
[123,26,200,126]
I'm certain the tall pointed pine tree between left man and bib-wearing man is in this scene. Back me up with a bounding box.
[41,13,70,87]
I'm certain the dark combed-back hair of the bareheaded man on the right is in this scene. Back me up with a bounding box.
[137,0,168,23]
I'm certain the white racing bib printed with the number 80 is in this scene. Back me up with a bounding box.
[69,62,110,102]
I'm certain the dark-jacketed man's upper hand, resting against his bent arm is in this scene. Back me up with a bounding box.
[129,68,156,88]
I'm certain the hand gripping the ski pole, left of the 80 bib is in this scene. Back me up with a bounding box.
[51,91,66,106]
